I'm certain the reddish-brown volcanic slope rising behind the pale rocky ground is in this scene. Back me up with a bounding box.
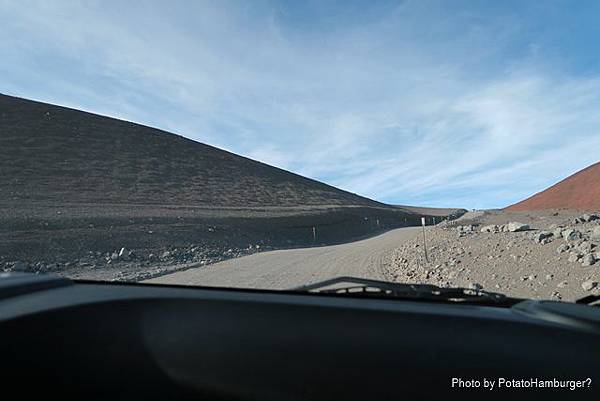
[506,163,600,211]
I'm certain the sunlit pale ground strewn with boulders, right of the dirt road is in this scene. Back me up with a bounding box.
[385,210,600,301]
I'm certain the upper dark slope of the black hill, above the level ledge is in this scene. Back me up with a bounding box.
[0,95,383,207]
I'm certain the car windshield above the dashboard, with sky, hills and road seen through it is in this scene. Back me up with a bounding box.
[0,1,600,301]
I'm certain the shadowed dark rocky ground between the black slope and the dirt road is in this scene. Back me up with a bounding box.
[0,202,454,281]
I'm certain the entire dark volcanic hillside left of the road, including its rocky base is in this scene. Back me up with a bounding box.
[0,95,464,268]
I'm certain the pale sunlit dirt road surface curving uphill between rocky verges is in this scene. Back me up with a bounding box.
[145,227,421,289]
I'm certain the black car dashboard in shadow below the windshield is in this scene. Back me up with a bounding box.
[0,274,600,400]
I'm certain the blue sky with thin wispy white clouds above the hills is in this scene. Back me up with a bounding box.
[0,0,600,208]
